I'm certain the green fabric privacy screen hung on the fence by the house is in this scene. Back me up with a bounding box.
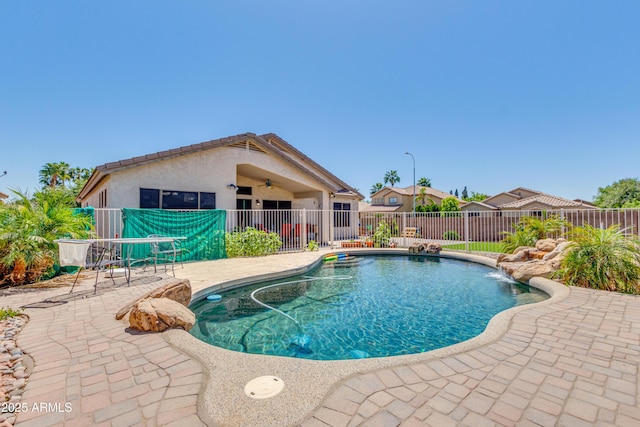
[122,208,227,261]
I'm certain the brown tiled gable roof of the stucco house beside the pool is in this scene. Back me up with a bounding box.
[78,133,364,201]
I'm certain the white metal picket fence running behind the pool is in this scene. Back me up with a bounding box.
[87,209,640,252]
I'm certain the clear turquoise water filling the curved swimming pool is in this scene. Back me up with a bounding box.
[190,256,549,360]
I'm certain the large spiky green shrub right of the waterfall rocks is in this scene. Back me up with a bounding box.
[554,224,640,294]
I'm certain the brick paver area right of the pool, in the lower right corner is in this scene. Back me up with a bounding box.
[302,288,640,427]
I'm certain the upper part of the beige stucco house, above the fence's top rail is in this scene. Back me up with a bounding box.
[77,133,363,210]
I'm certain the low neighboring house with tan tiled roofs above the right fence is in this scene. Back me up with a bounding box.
[461,187,597,212]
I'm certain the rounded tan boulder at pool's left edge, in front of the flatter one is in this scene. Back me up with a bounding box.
[129,298,196,332]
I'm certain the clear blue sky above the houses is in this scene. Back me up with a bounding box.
[0,0,640,200]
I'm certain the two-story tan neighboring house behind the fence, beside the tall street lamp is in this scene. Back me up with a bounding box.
[362,185,464,212]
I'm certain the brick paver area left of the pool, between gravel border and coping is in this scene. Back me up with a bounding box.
[3,282,204,427]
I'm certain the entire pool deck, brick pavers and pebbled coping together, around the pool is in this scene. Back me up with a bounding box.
[0,249,640,427]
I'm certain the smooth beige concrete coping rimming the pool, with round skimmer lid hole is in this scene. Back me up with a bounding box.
[163,249,570,427]
